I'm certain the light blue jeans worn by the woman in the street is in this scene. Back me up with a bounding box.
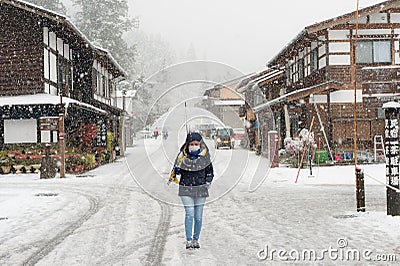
[181,196,207,241]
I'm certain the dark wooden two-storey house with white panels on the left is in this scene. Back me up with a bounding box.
[0,0,126,155]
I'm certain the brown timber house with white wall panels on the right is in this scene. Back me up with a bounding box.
[250,0,400,160]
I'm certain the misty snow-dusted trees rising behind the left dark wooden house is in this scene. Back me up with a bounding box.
[25,0,208,130]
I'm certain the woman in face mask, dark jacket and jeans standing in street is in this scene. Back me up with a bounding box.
[169,132,214,249]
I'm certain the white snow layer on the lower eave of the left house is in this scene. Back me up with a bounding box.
[0,93,107,113]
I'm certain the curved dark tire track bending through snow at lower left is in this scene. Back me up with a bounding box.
[23,191,100,265]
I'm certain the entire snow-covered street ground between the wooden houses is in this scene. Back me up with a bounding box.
[0,140,400,265]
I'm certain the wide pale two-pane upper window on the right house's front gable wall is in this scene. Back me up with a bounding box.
[356,40,392,64]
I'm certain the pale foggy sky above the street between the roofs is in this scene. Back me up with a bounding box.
[128,0,383,73]
